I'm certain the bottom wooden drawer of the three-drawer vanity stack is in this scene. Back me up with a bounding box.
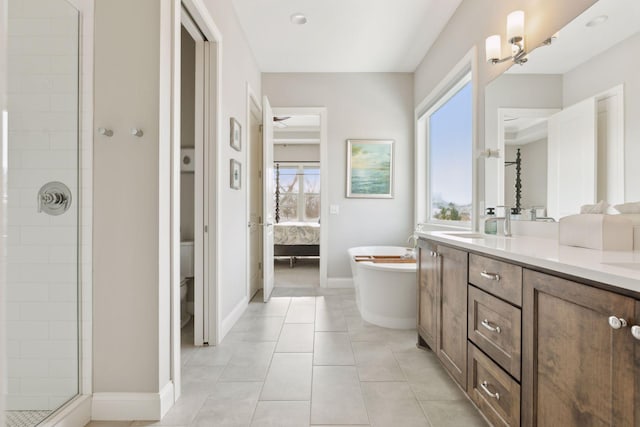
[467,343,520,426]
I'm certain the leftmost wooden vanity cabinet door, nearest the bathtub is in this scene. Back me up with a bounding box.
[418,239,440,351]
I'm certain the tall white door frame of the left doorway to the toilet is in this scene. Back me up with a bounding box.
[170,0,222,401]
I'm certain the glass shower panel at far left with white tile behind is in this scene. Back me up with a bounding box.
[5,0,79,427]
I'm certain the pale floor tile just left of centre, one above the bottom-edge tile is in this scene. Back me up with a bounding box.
[260,353,312,401]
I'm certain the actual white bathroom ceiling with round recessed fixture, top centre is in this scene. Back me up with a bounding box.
[233,0,462,72]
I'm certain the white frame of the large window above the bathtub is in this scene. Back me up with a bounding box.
[414,47,479,230]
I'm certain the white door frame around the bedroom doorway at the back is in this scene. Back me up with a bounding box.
[273,107,329,288]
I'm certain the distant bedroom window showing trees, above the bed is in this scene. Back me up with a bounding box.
[274,164,320,222]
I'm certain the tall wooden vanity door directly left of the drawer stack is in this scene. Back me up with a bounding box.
[436,246,469,390]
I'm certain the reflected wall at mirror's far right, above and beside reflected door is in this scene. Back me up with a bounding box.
[563,34,640,202]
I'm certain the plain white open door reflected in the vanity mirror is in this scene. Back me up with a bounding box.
[547,98,598,218]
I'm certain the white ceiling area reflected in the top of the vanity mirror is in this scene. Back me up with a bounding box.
[507,0,640,74]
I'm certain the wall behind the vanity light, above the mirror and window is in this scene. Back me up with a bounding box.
[414,0,595,216]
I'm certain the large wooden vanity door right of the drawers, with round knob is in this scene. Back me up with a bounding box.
[522,270,640,427]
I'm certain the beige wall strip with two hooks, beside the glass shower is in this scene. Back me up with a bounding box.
[93,0,164,393]
